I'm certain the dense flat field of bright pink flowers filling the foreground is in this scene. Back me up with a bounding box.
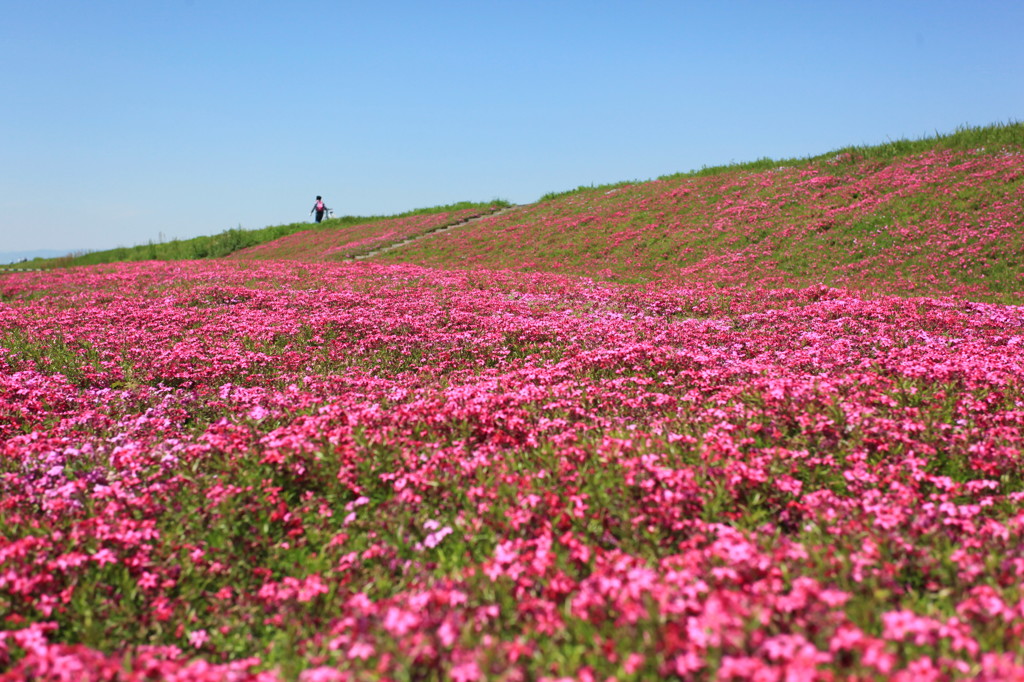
[0,261,1024,682]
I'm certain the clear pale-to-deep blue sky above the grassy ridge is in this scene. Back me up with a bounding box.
[0,0,1024,252]
